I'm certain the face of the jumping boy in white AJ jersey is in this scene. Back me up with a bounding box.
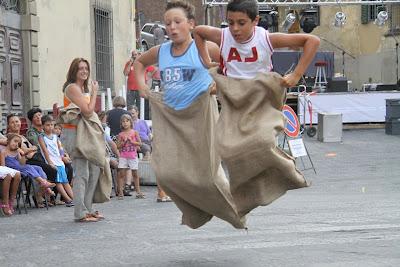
[226,11,259,43]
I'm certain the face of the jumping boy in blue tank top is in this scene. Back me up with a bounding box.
[164,8,194,43]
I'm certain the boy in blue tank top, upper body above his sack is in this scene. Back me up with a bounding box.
[134,1,219,110]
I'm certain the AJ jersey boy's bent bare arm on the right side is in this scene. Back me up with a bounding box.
[270,33,320,87]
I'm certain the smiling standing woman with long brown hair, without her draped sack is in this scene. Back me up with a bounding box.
[63,58,104,222]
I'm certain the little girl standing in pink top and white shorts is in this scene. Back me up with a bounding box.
[117,114,145,199]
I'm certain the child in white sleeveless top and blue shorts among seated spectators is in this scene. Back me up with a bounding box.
[39,115,74,207]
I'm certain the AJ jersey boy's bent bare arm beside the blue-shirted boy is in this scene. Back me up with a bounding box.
[193,25,221,68]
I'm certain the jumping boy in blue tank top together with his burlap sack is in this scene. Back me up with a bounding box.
[134,0,245,228]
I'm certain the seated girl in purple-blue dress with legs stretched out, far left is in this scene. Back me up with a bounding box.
[0,133,56,196]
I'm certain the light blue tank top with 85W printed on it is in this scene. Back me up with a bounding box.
[158,41,212,110]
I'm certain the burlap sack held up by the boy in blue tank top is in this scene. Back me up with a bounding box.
[149,92,245,228]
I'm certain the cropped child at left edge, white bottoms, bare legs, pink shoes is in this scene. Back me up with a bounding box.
[0,166,21,216]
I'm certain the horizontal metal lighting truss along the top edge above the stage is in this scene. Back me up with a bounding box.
[203,0,400,6]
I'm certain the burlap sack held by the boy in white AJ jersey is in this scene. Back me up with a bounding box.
[210,68,307,219]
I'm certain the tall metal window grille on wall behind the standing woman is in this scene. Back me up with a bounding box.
[94,0,114,90]
